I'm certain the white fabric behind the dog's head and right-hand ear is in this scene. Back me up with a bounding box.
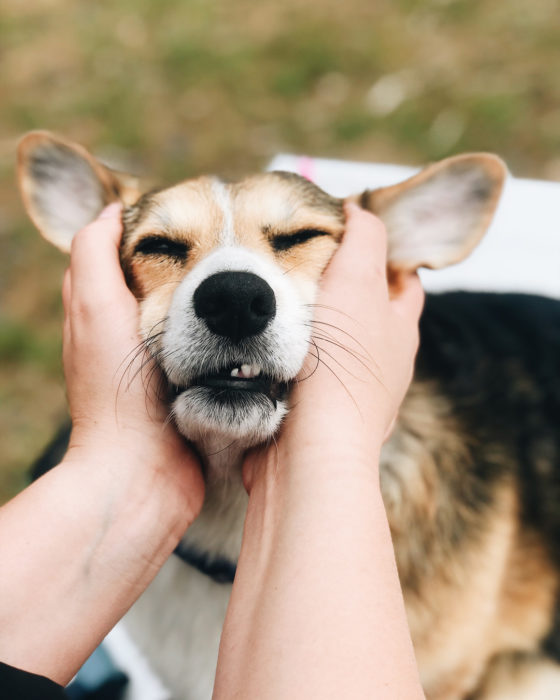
[268,155,560,298]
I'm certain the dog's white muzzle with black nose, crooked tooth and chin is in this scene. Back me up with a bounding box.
[161,254,309,447]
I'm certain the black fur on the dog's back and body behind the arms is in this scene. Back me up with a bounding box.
[29,292,560,661]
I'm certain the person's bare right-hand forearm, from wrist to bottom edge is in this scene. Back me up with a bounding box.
[215,446,423,700]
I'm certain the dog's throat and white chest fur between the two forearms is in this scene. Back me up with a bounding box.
[124,446,247,700]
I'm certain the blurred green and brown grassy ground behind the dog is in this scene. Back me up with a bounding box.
[0,0,560,502]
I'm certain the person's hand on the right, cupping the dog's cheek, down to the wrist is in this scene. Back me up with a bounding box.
[246,202,424,482]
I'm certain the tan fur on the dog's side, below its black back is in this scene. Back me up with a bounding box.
[381,382,558,700]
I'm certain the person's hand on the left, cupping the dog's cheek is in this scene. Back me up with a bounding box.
[63,204,204,514]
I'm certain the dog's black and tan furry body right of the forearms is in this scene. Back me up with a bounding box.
[382,292,560,700]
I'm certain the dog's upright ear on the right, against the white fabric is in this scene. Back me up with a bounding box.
[358,153,507,270]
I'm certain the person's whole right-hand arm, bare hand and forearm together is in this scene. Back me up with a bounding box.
[214,205,424,700]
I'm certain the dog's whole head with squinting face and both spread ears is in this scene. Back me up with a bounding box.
[19,132,506,445]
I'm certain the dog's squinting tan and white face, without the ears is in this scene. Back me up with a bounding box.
[121,173,344,442]
